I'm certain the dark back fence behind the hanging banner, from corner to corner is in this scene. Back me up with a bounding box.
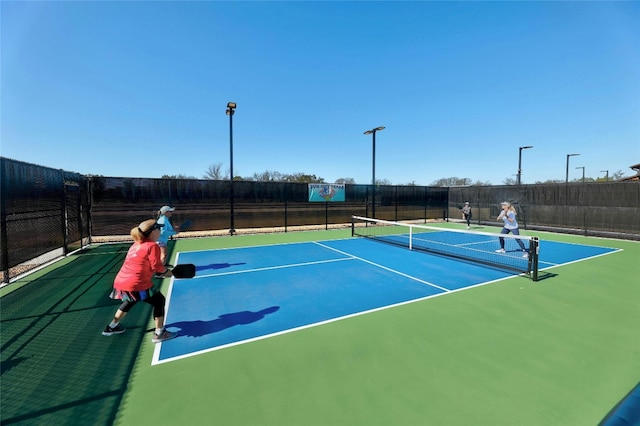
[89,177,448,236]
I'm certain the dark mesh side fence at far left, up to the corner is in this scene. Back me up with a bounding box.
[0,158,89,282]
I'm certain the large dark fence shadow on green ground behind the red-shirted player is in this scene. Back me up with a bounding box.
[0,244,156,425]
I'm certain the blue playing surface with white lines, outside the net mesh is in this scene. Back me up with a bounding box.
[152,238,617,364]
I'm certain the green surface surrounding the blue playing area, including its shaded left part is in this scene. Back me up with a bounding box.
[0,225,640,426]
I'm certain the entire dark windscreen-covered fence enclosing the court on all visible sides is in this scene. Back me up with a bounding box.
[0,158,640,282]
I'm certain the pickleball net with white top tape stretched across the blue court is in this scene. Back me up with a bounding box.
[351,216,540,281]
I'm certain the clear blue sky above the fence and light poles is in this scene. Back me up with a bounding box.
[0,1,640,185]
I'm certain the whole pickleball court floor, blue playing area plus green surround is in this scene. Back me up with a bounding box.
[2,225,640,425]
